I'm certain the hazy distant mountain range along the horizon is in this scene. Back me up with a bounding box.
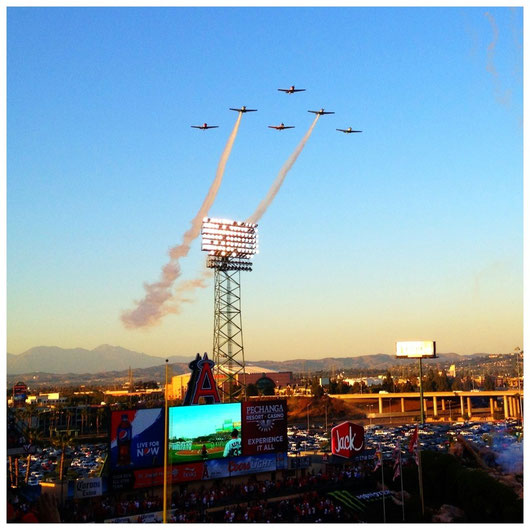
[7,344,487,376]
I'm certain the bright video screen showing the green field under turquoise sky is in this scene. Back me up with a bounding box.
[168,403,241,464]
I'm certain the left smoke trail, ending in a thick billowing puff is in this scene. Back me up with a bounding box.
[121,112,242,328]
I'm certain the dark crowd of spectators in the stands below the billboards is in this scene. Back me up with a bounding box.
[12,462,374,523]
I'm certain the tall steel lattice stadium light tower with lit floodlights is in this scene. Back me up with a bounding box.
[201,217,258,402]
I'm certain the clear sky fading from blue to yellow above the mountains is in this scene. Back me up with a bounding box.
[7,7,523,360]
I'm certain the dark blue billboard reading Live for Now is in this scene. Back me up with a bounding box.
[110,408,164,471]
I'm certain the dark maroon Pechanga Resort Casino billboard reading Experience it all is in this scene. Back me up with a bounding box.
[241,399,288,455]
